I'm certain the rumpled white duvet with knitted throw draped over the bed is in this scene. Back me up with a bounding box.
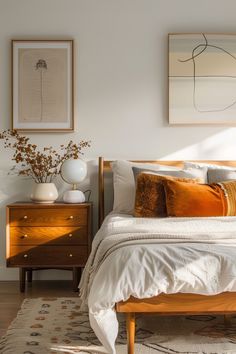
[80,214,236,353]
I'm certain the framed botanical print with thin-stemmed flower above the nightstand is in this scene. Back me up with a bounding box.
[12,40,74,132]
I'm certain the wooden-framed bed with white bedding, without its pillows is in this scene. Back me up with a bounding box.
[80,158,236,354]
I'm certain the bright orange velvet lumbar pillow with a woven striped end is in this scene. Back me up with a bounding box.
[163,180,236,217]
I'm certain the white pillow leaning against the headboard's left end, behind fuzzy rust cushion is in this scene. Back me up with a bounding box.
[111,160,179,214]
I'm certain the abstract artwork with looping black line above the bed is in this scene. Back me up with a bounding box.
[169,33,236,125]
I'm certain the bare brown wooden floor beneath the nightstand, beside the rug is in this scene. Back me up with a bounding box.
[0,280,78,337]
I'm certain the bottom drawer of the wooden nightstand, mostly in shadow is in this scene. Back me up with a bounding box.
[7,246,88,267]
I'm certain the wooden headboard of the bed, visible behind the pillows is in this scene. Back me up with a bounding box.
[98,157,236,227]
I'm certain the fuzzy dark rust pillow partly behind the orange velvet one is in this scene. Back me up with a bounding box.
[134,172,199,217]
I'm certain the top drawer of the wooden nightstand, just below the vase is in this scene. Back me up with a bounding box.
[9,207,87,227]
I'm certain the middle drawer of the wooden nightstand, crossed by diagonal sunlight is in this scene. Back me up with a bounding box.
[10,226,88,246]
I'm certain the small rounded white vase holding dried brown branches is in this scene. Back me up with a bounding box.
[30,183,58,204]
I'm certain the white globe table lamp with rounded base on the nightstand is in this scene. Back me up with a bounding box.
[61,159,87,203]
